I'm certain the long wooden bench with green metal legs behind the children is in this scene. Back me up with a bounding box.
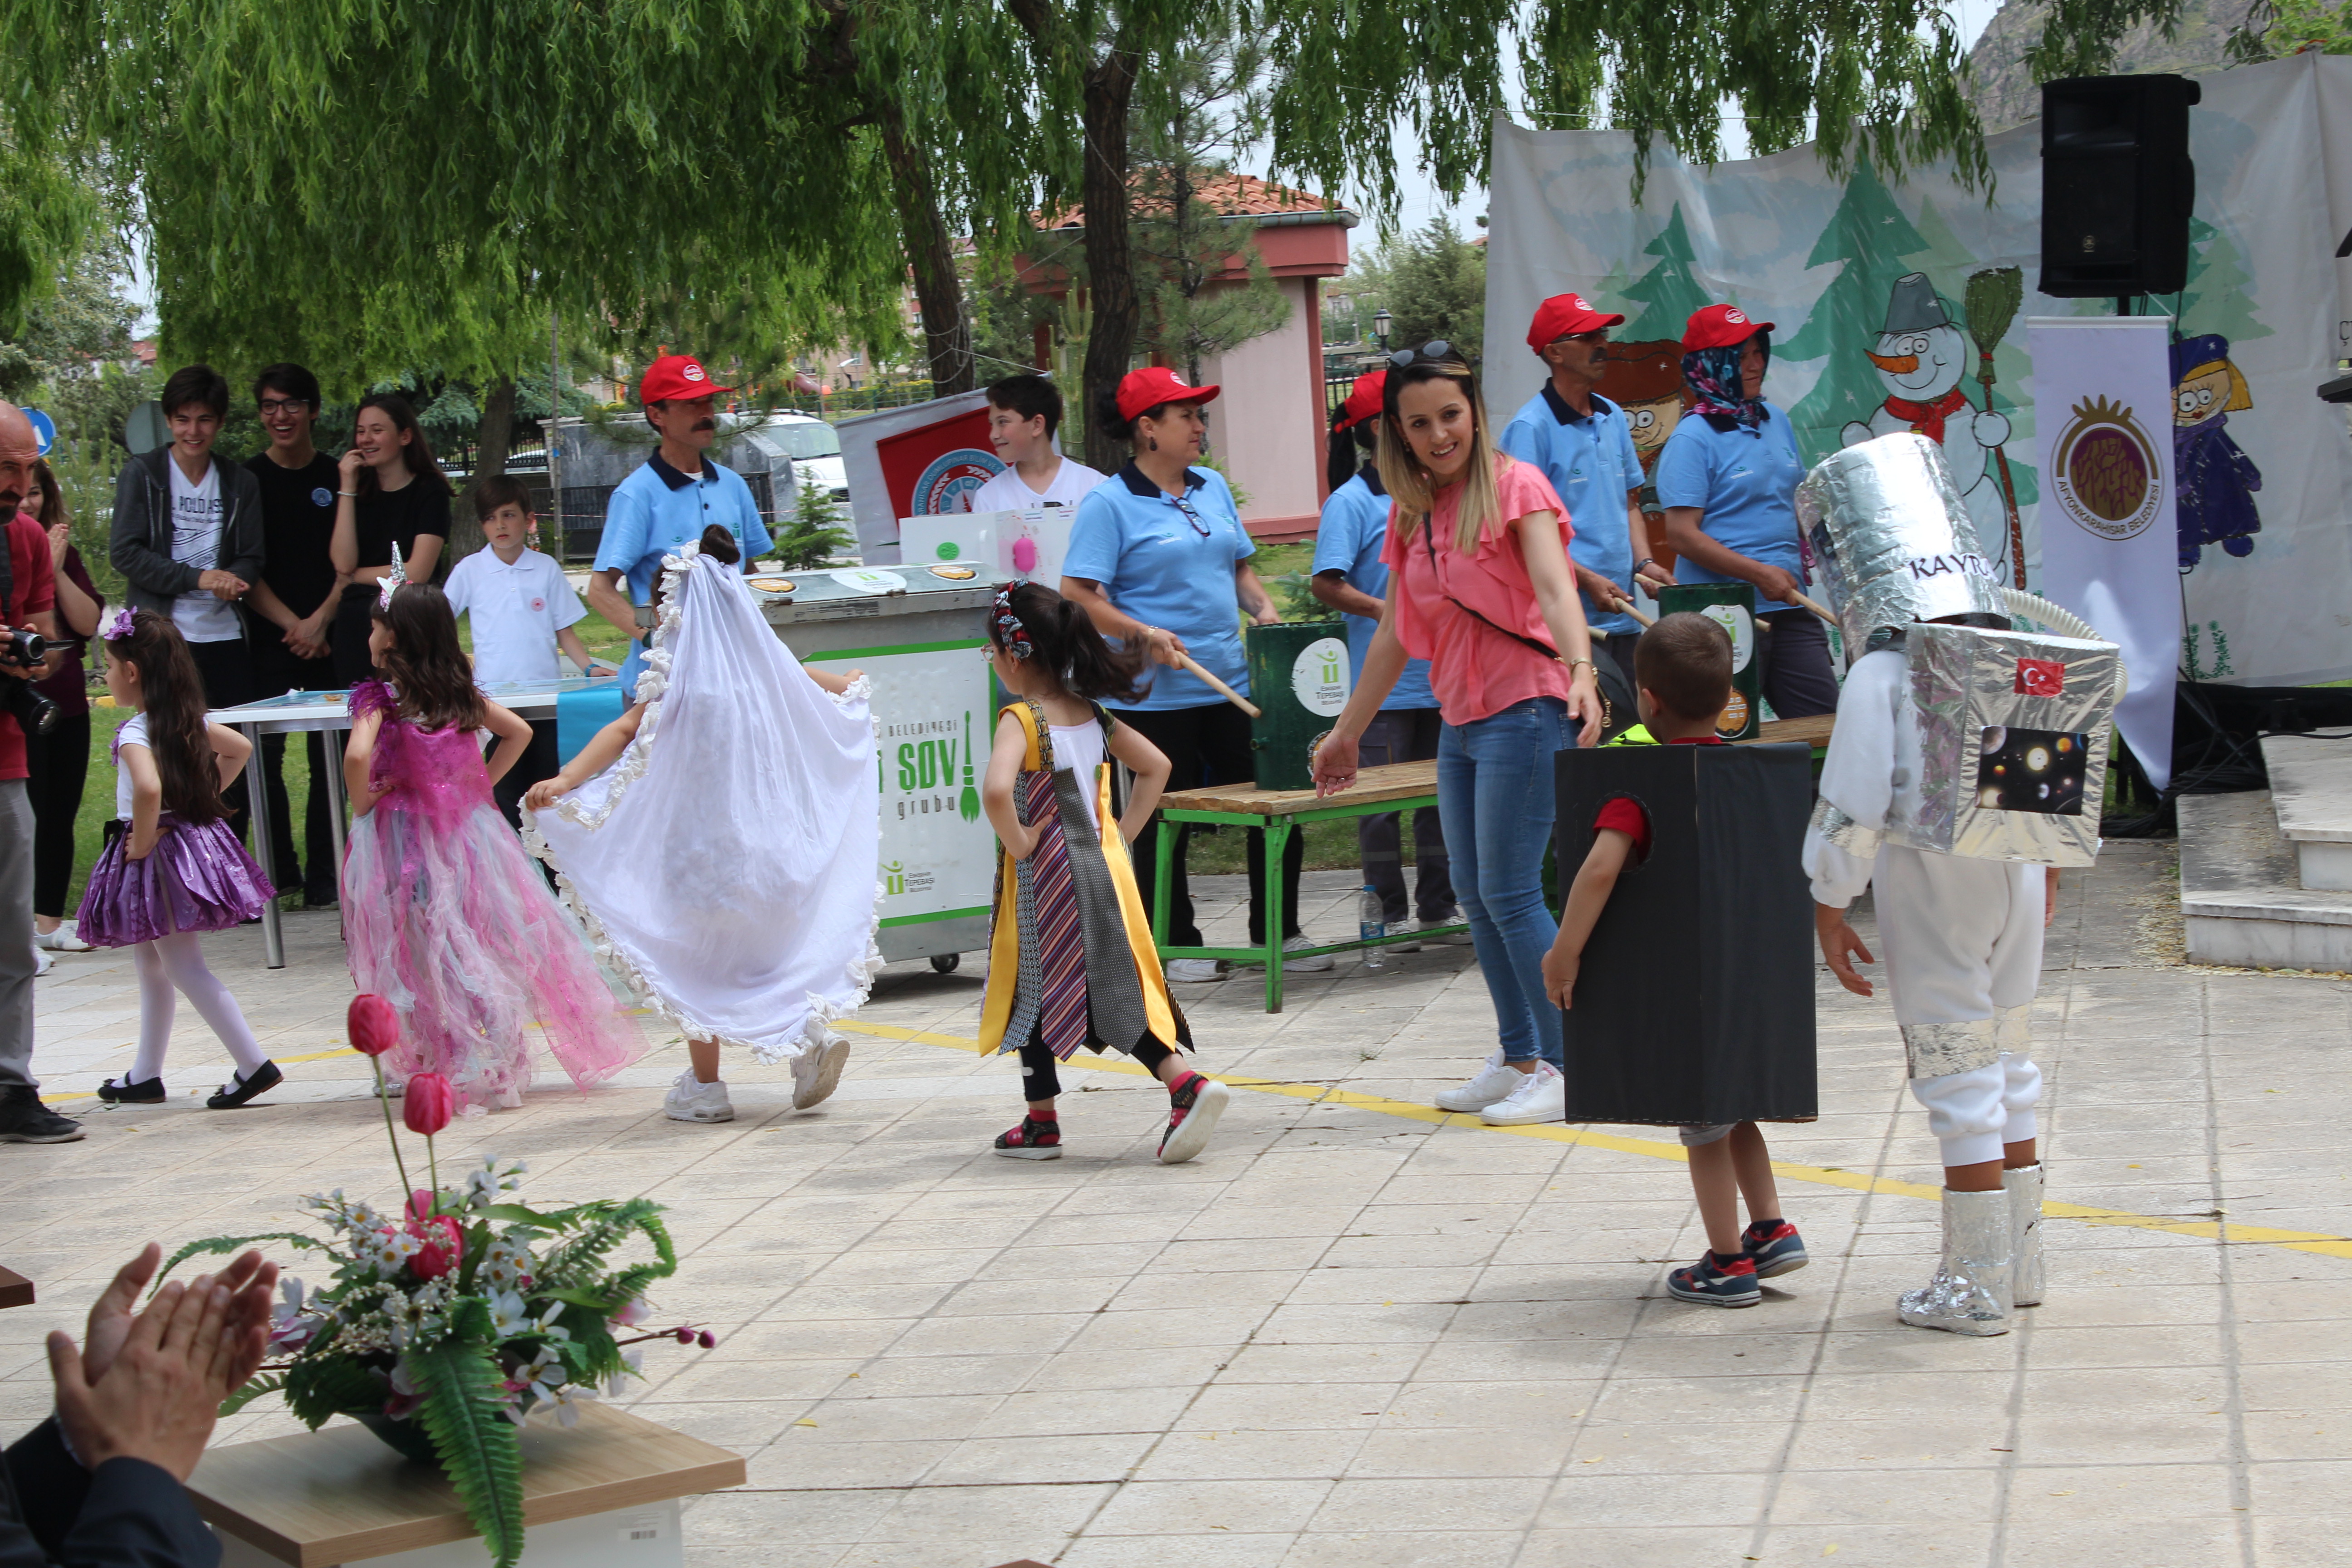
[1152,712,1837,1013]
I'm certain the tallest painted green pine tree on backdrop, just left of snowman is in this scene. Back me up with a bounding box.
[1774,157,1929,463]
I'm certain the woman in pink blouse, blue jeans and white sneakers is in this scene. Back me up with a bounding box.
[1315,343,1602,1126]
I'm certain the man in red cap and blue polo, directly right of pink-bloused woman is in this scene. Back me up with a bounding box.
[1498,294,1672,691]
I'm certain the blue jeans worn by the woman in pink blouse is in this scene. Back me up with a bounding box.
[1437,696,1576,1067]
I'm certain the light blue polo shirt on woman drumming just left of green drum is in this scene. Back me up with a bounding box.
[1061,463,1258,712]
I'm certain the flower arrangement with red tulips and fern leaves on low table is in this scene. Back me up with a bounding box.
[157,997,715,1568]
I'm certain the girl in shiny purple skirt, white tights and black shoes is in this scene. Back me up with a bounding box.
[75,609,284,1110]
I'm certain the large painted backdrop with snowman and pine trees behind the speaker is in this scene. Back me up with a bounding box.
[1484,54,2352,684]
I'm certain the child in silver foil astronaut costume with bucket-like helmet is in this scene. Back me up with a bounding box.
[1797,432,2122,1335]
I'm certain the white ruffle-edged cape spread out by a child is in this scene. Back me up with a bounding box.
[522,545,882,1063]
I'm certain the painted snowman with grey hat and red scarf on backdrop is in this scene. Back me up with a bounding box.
[1839,273,2009,576]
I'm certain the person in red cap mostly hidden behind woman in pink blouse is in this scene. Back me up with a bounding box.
[1308,369,1470,952]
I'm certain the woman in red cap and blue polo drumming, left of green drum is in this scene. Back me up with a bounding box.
[1061,364,1298,980]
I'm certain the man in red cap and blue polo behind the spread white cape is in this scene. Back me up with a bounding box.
[588,355,769,698]
